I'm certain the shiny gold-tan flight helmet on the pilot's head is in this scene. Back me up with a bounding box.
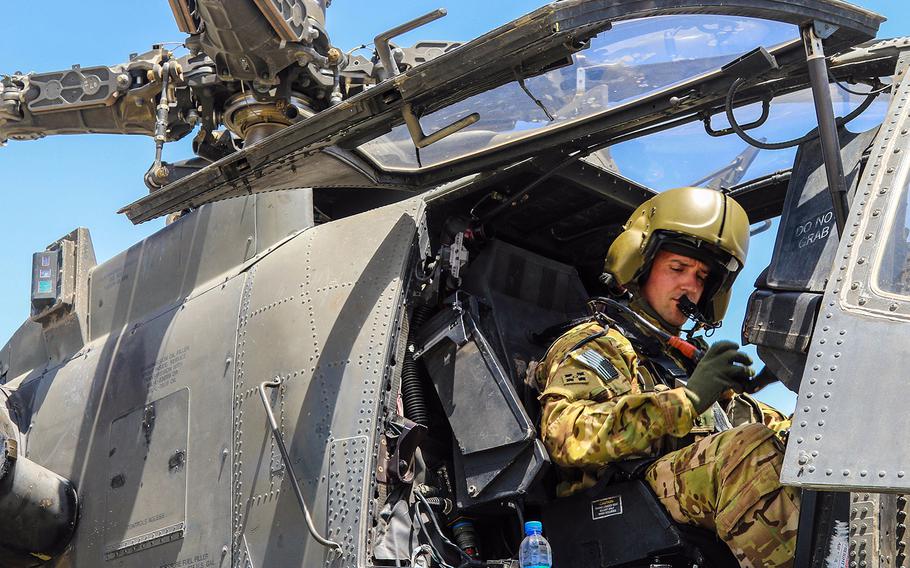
[603,187,749,325]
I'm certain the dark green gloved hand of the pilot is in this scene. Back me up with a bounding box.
[686,341,754,414]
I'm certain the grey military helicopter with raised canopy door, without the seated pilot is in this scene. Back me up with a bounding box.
[0,0,910,568]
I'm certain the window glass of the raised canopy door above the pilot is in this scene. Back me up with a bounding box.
[360,15,799,170]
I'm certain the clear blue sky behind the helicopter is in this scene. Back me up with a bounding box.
[0,0,910,410]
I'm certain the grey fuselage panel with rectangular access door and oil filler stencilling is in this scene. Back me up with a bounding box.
[7,276,245,568]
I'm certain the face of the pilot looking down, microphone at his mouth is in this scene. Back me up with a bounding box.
[641,251,710,327]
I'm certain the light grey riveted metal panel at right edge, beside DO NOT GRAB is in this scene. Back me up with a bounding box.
[781,58,910,491]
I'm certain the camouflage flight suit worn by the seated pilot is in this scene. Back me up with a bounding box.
[535,322,799,566]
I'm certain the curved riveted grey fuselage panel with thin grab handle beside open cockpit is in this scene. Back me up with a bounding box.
[233,200,422,566]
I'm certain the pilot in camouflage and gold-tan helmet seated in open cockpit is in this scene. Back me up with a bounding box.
[534,187,799,567]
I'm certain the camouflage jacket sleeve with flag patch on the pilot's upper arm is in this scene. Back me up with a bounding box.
[541,330,695,468]
